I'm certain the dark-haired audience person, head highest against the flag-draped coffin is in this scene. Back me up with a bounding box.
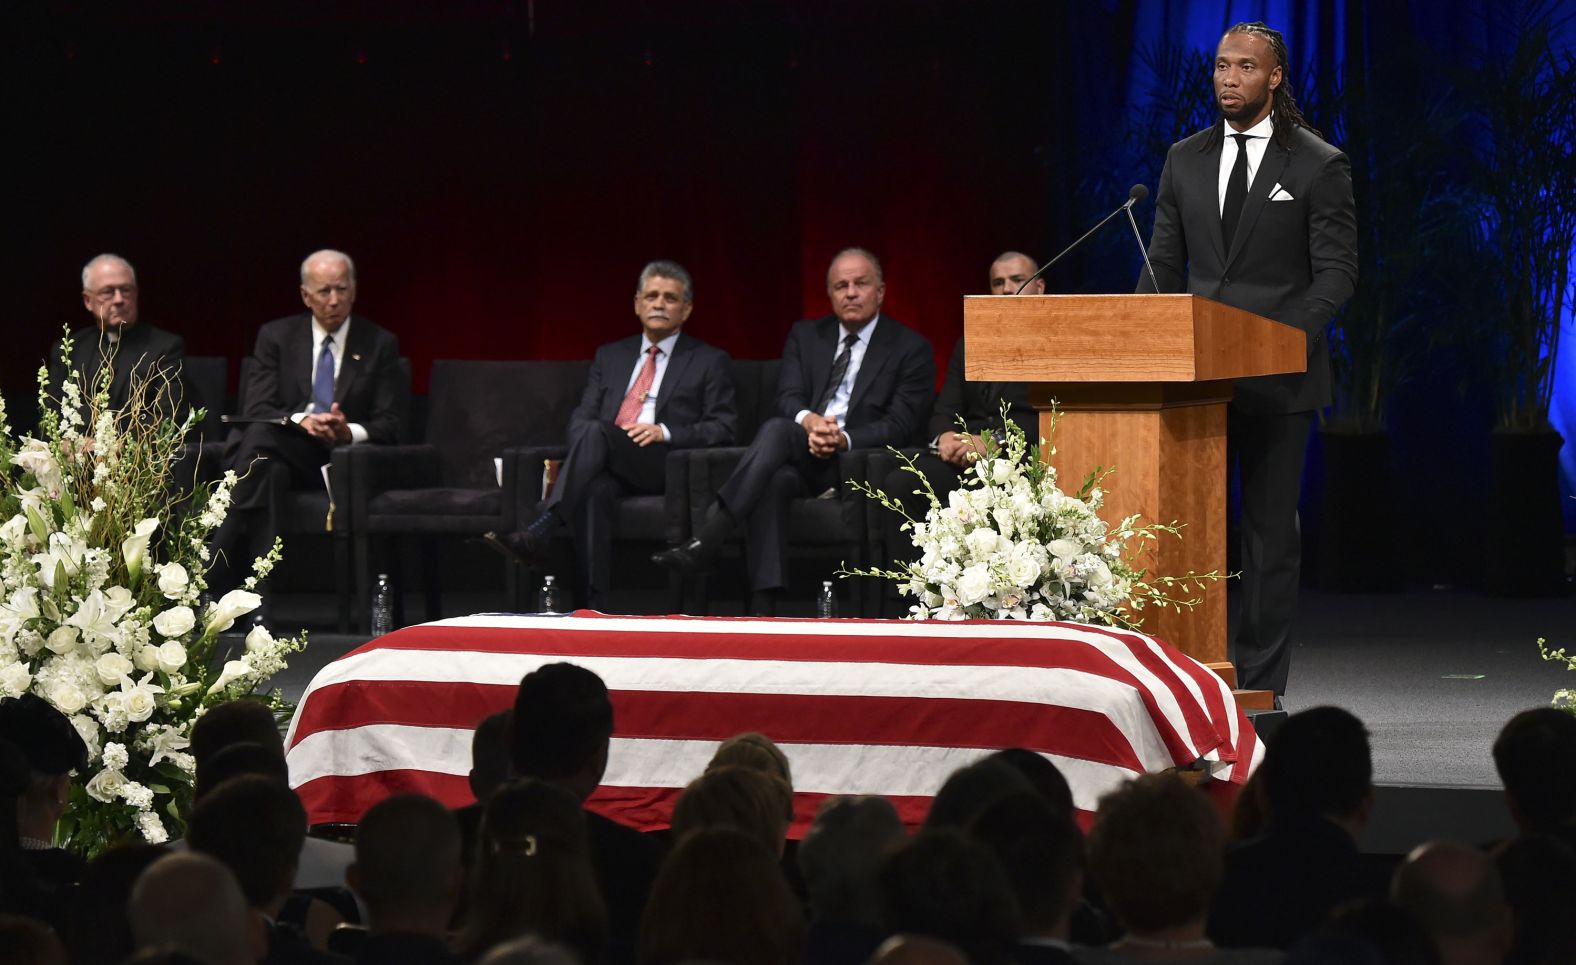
[511,664,662,965]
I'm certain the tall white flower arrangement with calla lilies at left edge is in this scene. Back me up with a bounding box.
[0,329,306,855]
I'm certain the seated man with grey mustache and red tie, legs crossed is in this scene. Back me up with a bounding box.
[487,262,734,609]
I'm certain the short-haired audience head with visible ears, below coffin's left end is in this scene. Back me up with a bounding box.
[345,795,462,935]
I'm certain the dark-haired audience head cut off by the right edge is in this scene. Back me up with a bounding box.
[1494,706,1576,831]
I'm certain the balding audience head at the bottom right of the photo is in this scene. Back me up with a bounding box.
[1390,840,1513,962]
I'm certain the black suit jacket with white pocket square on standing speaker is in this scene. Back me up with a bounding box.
[1138,121,1357,413]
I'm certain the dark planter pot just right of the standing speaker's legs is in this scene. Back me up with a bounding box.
[1314,432,1406,593]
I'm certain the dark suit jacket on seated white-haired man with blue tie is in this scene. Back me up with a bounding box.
[241,314,410,443]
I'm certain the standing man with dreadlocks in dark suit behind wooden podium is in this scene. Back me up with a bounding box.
[1138,22,1357,699]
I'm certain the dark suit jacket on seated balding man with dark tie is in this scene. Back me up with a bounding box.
[777,315,936,449]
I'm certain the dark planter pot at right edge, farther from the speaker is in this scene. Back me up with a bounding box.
[1481,429,1570,596]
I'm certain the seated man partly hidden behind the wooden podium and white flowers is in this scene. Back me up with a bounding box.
[881,251,1045,617]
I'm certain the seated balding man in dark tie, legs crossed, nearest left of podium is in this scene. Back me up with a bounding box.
[652,248,936,613]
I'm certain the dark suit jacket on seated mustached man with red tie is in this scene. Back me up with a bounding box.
[569,334,736,449]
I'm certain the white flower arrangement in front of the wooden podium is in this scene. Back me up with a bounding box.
[838,405,1223,629]
